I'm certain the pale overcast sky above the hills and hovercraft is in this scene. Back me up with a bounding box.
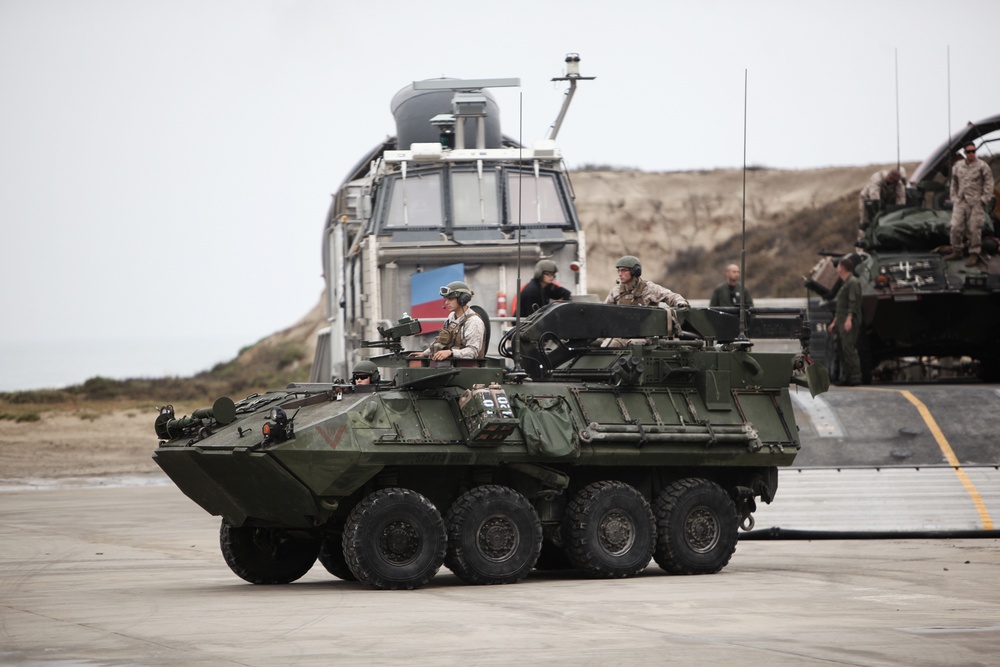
[0,0,1000,388]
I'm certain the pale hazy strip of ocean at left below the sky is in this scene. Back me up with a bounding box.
[0,337,254,391]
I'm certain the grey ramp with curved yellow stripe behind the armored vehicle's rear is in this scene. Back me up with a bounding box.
[755,384,1000,532]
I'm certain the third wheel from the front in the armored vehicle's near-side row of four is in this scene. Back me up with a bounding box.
[563,481,656,579]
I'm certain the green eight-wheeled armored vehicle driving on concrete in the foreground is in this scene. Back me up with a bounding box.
[153,301,826,589]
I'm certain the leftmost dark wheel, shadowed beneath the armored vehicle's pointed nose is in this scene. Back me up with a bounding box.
[219,519,319,584]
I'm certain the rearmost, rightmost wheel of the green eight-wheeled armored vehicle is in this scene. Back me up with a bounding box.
[654,478,739,574]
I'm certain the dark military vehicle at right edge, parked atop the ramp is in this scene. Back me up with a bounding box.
[806,116,1000,382]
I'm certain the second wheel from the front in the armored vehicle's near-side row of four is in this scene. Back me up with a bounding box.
[445,485,542,584]
